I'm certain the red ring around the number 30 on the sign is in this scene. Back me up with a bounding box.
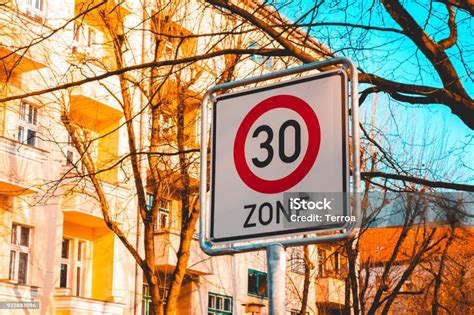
[234,95,321,194]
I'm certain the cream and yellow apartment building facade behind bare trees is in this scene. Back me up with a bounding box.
[0,0,347,315]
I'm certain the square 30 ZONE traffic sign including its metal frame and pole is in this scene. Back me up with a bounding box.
[200,58,360,314]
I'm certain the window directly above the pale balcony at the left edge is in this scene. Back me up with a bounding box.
[17,101,38,146]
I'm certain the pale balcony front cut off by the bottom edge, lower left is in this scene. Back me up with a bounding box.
[54,295,125,314]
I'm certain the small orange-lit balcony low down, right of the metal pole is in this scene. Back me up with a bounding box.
[316,277,345,307]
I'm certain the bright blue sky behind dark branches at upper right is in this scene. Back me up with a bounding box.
[277,1,474,184]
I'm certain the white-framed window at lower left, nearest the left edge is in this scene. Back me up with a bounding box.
[9,223,31,284]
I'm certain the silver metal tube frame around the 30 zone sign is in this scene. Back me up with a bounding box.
[199,57,360,256]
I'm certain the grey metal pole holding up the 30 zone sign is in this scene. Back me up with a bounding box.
[267,244,286,315]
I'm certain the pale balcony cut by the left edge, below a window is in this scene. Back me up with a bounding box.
[0,136,48,195]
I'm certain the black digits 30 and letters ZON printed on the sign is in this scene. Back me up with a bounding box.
[244,119,301,228]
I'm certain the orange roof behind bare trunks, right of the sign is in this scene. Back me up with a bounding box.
[359,227,474,264]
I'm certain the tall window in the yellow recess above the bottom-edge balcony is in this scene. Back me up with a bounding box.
[59,238,86,296]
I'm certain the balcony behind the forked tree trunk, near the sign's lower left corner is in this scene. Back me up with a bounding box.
[155,230,212,275]
